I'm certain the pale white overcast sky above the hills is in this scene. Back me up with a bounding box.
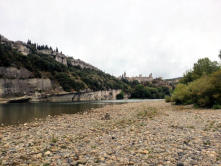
[0,0,221,78]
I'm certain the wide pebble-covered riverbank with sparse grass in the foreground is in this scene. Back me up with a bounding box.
[0,101,221,165]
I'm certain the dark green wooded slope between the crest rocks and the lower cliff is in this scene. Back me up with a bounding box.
[0,35,127,92]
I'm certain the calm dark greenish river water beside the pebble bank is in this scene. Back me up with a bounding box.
[0,100,161,125]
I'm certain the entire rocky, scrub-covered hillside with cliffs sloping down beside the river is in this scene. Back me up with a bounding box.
[0,35,126,101]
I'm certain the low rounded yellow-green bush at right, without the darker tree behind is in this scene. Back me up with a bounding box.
[171,70,221,107]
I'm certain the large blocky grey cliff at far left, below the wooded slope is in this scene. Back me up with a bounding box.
[0,67,55,97]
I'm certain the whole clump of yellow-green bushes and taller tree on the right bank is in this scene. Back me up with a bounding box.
[166,52,221,108]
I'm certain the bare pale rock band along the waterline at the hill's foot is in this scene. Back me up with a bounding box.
[0,67,120,102]
